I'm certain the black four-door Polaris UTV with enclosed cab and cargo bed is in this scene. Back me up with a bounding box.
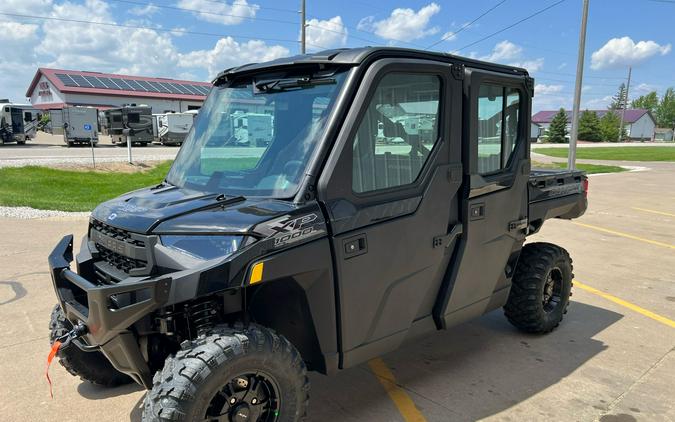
[49,48,588,421]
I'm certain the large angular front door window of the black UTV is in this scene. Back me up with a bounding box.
[352,73,441,193]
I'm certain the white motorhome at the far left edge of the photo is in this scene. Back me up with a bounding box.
[0,100,40,145]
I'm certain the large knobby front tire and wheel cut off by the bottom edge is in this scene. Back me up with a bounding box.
[143,325,309,422]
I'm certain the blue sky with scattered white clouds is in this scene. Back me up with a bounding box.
[0,0,675,112]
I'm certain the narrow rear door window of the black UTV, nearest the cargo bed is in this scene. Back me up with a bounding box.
[478,84,520,174]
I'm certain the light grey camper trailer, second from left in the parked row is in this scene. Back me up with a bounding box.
[49,107,98,147]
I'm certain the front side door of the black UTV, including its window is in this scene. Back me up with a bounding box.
[318,59,462,367]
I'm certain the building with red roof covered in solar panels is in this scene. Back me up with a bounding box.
[26,67,211,113]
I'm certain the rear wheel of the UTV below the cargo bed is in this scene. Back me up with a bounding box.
[504,243,574,333]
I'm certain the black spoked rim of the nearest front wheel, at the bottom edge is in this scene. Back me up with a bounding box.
[204,371,281,422]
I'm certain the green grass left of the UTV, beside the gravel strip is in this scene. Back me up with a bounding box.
[0,161,171,211]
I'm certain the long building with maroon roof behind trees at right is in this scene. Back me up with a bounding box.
[532,109,656,141]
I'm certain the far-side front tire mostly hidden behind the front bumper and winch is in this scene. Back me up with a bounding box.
[49,305,133,387]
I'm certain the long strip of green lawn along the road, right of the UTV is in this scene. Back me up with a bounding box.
[533,146,675,161]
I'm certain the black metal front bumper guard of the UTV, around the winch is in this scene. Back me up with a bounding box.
[49,235,172,388]
